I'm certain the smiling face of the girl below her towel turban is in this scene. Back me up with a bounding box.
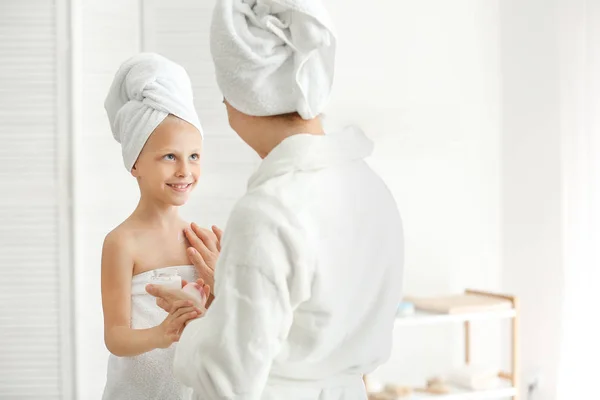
[131,115,202,206]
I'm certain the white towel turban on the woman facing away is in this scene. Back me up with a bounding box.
[210,0,336,119]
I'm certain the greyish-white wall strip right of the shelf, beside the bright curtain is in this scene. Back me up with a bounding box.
[500,0,564,400]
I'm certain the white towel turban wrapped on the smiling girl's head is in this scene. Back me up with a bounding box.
[104,53,202,171]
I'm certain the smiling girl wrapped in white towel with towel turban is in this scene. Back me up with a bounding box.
[102,54,218,400]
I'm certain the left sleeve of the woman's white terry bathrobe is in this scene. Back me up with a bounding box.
[174,198,310,400]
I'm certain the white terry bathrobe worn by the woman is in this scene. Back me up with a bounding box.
[174,129,403,400]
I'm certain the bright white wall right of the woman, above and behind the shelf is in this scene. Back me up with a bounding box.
[326,0,508,384]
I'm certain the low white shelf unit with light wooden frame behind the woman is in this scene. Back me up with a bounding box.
[365,289,519,400]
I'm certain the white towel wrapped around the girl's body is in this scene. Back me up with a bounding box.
[102,265,197,400]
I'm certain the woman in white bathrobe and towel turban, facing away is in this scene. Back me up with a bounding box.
[147,0,403,400]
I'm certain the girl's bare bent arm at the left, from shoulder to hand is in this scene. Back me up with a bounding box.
[102,232,197,357]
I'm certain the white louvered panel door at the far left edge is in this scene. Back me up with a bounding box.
[0,0,73,400]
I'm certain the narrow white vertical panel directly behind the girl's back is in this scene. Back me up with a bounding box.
[73,0,140,400]
